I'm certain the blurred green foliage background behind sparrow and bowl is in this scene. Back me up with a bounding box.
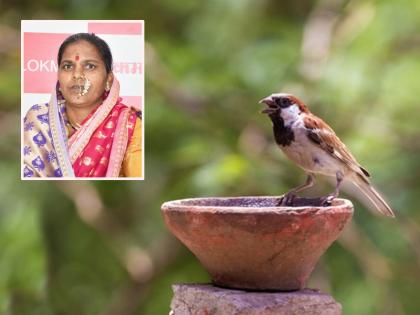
[0,0,420,315]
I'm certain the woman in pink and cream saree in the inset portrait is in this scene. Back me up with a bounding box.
[23,33,142,177]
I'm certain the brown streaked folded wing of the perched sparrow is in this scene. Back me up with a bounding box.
[303,114,370,180]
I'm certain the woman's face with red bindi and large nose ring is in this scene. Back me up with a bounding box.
[58,40,113,107]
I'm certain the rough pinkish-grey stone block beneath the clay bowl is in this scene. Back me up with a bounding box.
[170,284,341,315]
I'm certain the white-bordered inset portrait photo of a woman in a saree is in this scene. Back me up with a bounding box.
[21,20,144,179]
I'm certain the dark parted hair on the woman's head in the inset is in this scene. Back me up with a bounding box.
[57,33,112,74]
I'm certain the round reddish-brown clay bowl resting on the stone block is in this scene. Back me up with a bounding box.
[162,197,353,291]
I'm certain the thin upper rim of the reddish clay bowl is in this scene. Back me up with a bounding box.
[161,196,354,214]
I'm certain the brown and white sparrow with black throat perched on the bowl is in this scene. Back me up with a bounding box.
[260,93,395,217]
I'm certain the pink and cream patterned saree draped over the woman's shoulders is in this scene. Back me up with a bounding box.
[23,78,141,178]
